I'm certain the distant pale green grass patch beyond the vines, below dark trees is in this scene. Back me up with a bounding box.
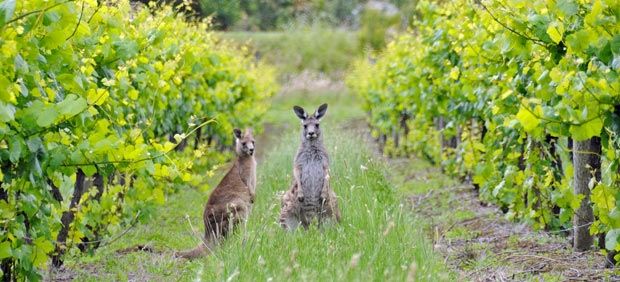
[218,26,360,75]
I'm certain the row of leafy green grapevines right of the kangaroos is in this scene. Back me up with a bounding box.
[348,0,620,256]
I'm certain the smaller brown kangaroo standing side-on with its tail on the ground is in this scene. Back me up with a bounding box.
[175,129,256,258]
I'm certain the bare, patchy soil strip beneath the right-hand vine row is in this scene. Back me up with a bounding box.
[389,155,620,281]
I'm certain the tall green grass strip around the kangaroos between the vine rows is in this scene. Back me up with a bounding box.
[61,90,450,281]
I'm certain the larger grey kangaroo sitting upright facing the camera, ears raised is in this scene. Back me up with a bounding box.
[280,104,340,230]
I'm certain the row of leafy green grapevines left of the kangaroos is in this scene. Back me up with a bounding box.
[0,0,274,280]
